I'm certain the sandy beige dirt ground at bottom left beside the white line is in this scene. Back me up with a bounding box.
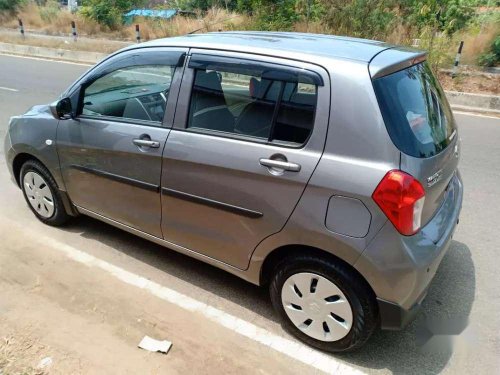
[0,219,316,375]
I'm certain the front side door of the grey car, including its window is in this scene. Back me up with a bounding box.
[57,48,186,237]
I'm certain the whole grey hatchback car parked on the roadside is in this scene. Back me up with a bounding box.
[5,32,463,352]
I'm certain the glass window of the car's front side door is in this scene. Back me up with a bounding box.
[82,65,175,122]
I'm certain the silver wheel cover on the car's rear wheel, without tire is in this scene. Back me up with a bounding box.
[281,272,353,342]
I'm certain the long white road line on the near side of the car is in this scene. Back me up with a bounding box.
[8,220,365,375]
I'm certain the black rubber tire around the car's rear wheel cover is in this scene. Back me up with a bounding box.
[269,255,379,353]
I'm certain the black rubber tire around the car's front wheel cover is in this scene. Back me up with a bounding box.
[19,160,70,227]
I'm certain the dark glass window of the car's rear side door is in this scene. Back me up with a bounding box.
[188,66,317,146]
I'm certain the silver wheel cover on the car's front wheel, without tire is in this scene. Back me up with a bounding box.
[23,171,54,219]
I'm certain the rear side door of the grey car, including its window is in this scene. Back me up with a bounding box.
[161,50,330,269]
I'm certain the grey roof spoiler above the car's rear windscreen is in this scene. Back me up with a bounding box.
[368,47,427,79]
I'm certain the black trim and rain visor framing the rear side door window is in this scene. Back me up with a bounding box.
[185,53,324,150]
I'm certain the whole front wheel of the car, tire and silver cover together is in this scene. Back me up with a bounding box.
[20,160,69,226]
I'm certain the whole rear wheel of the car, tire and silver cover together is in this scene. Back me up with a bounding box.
[270,256,378,352]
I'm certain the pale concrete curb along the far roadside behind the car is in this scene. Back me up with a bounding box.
[0,42,500,114]
